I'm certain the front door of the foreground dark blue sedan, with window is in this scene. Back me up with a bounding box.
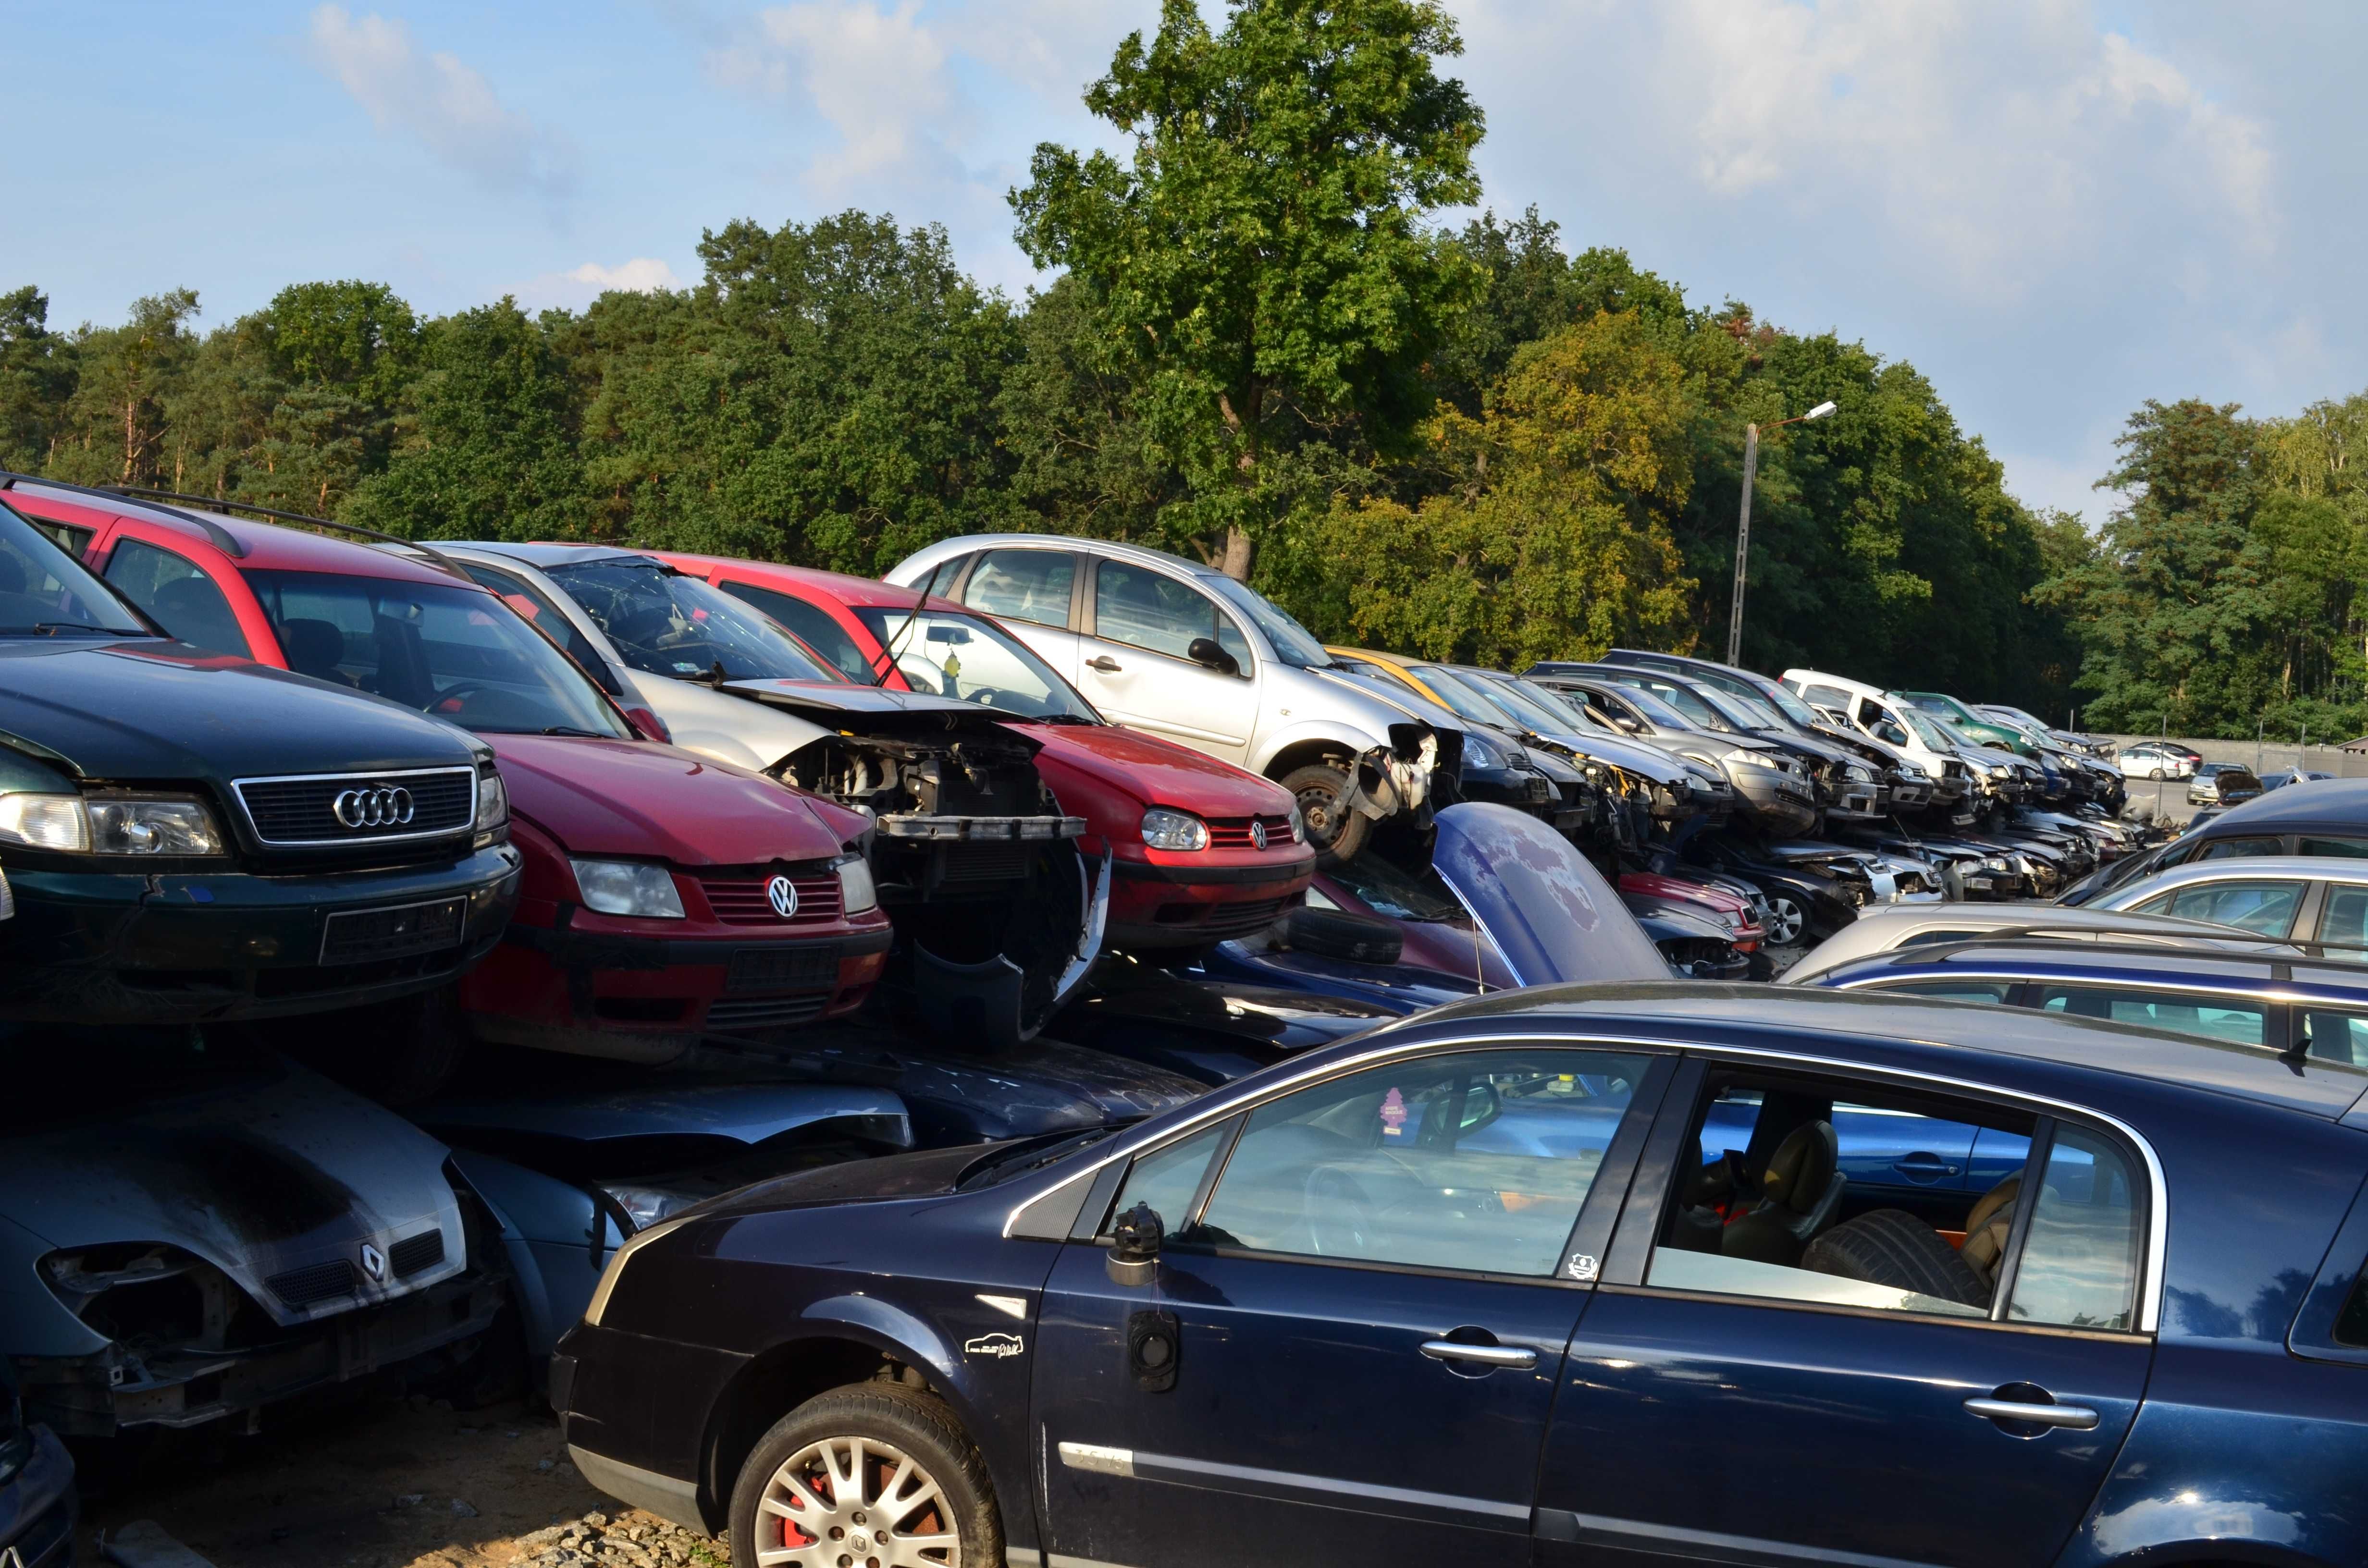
[1033,1044,1669,1568]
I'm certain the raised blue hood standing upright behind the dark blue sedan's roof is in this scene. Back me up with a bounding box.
[1431,801,1669,985]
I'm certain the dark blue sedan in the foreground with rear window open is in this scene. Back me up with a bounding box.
[552,983,2368,1568]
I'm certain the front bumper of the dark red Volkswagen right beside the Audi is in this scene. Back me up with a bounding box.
[459,907,893,1064]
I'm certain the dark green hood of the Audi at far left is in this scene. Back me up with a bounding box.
[0,642,485,782]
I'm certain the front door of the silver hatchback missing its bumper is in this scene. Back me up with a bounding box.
[1077,559,1258,763]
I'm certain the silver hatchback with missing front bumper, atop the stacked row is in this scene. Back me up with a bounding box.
[886,533,1464,862]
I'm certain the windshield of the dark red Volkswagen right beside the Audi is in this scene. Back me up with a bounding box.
[242,571,632,739]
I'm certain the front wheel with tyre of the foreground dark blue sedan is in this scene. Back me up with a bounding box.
[729,1383,1004,1568]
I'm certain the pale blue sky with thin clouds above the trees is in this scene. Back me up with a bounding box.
[0,0,2368,521]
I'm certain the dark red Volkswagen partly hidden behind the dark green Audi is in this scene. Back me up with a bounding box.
[10,483,888,1099]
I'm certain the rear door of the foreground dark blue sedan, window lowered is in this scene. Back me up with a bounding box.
[1537,1059,2159,1568]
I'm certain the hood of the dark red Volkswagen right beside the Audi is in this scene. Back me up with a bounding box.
[488,734,840,867]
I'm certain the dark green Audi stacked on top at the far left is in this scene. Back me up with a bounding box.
[0,481,518,1023]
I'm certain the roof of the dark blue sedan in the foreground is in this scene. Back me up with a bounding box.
[1382,980,2368,1120]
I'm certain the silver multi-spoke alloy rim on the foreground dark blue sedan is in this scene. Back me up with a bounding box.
[755,1438,962,1568]
